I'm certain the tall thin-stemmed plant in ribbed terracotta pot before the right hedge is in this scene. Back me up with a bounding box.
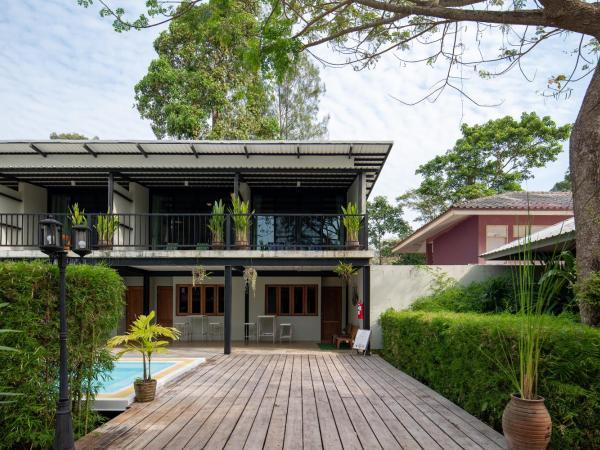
[502,237,566,450]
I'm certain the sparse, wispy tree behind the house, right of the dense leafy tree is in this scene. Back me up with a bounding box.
[275,54,329,140]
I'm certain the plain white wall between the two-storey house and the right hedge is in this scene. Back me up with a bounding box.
[368,265,509,348]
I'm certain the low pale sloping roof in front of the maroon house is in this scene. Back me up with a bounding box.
[481,217,575,260]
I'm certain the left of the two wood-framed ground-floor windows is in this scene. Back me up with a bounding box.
[176,284,225,316]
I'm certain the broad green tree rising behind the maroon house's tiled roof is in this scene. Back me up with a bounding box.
[399,113,571,221]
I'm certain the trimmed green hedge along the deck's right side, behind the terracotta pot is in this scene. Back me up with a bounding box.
[380,310,600,449]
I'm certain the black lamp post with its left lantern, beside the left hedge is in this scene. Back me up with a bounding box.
[40,216,75,450]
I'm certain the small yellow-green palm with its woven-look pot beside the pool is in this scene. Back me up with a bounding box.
[108,311,180,402]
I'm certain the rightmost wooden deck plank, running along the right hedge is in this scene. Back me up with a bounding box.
[373,357,506,448]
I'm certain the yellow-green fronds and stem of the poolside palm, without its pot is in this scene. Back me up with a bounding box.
[108,311,180,382]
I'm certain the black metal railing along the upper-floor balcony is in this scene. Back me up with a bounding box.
[0,213,368,251]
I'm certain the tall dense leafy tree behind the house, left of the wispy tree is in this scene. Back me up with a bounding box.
[135,0,278,139]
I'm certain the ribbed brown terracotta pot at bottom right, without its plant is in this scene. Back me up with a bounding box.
[502,394,552,450]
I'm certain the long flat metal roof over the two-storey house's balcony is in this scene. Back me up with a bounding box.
[0,139,393,192]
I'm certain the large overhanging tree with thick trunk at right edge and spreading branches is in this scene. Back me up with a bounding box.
[78,0,600,325]
